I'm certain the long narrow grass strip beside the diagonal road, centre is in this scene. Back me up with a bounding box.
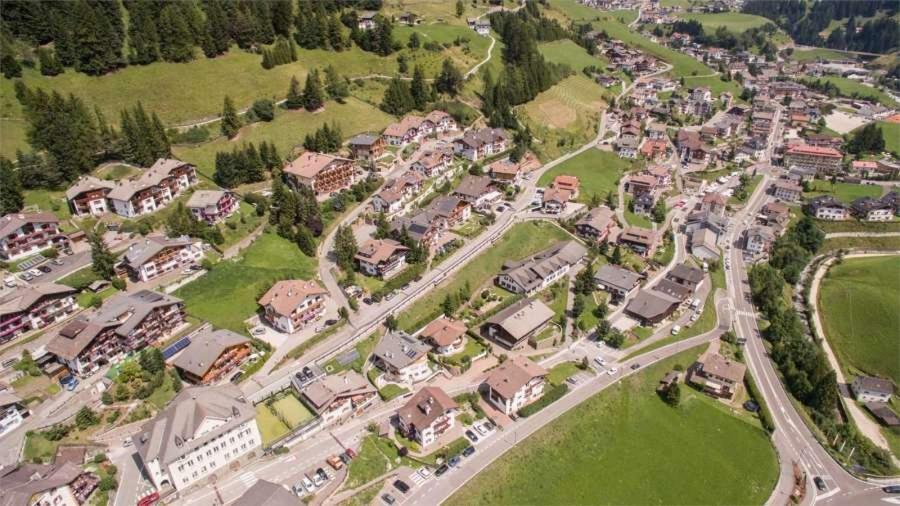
[398,222,571,332]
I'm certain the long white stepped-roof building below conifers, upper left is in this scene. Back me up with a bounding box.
[106,158,197,218]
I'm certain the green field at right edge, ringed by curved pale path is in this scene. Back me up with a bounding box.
[816,256,900,383]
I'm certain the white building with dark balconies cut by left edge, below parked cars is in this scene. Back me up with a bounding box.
[0,283,78,343]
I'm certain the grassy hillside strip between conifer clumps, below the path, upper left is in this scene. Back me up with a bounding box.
[172,97,394,177]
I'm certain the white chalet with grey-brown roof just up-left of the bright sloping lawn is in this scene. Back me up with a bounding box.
[116,235,203,283]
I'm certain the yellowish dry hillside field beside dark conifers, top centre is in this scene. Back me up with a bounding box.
[520,74,608,160]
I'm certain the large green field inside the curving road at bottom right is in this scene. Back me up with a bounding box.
[445,348,778,506]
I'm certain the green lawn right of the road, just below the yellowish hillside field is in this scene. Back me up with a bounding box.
[538,149,632,203]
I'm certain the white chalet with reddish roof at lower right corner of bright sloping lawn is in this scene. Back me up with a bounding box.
[258,279,328,334]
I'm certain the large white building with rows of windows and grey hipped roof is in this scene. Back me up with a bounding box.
[133,384,262,490]
